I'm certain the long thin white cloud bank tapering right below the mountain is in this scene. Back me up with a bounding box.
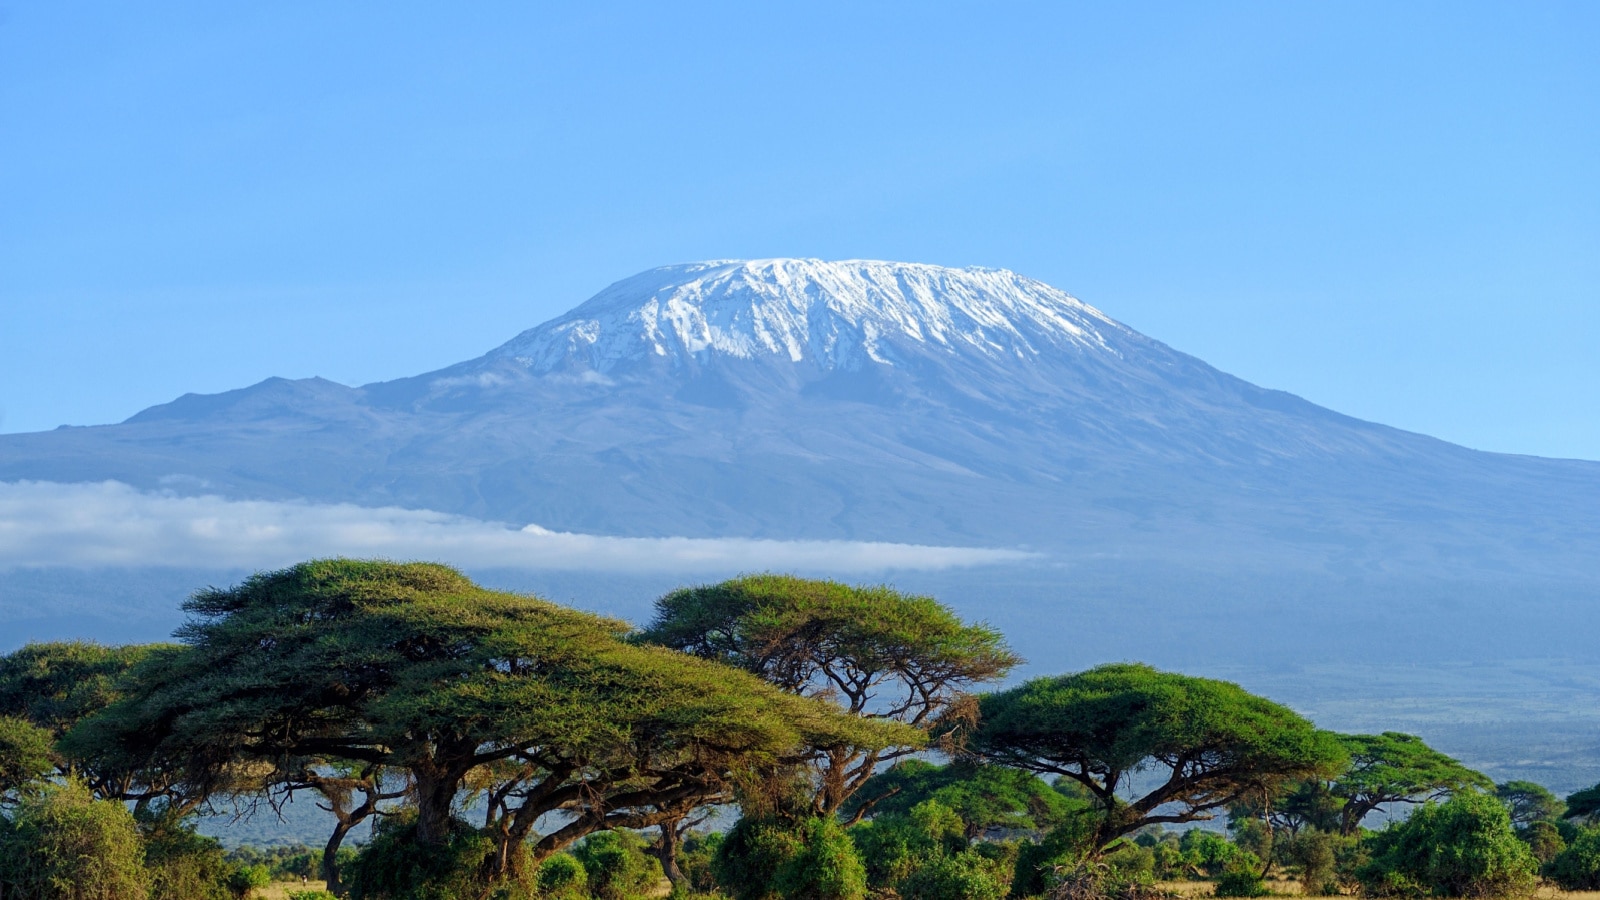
[0,482,1037,572]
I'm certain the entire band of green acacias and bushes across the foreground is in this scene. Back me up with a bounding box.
[0,559,1600,900]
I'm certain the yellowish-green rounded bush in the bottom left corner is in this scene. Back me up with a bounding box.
[0,781,149,900]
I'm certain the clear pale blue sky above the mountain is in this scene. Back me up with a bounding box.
[0,0,1600,458]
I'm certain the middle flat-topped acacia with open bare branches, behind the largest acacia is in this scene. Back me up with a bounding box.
[640,575,1019,822]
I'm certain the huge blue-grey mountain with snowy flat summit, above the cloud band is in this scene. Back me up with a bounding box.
[0,259,1600,583]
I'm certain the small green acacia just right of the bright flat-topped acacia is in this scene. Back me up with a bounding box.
[1328,732,1494,834]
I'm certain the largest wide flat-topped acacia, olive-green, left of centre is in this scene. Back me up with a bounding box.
[69,559,902,874]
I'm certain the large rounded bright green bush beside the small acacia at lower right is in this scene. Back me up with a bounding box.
[1360,791,1538,897]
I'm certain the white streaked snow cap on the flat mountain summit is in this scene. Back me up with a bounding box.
[490,259,1125,373]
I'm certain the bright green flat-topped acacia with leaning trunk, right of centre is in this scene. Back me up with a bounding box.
[970,665,1346,854]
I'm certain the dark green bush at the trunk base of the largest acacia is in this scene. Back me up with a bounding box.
[342,814,494,900]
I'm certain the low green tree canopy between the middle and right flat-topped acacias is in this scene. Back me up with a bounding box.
[843,759,1090,838]
